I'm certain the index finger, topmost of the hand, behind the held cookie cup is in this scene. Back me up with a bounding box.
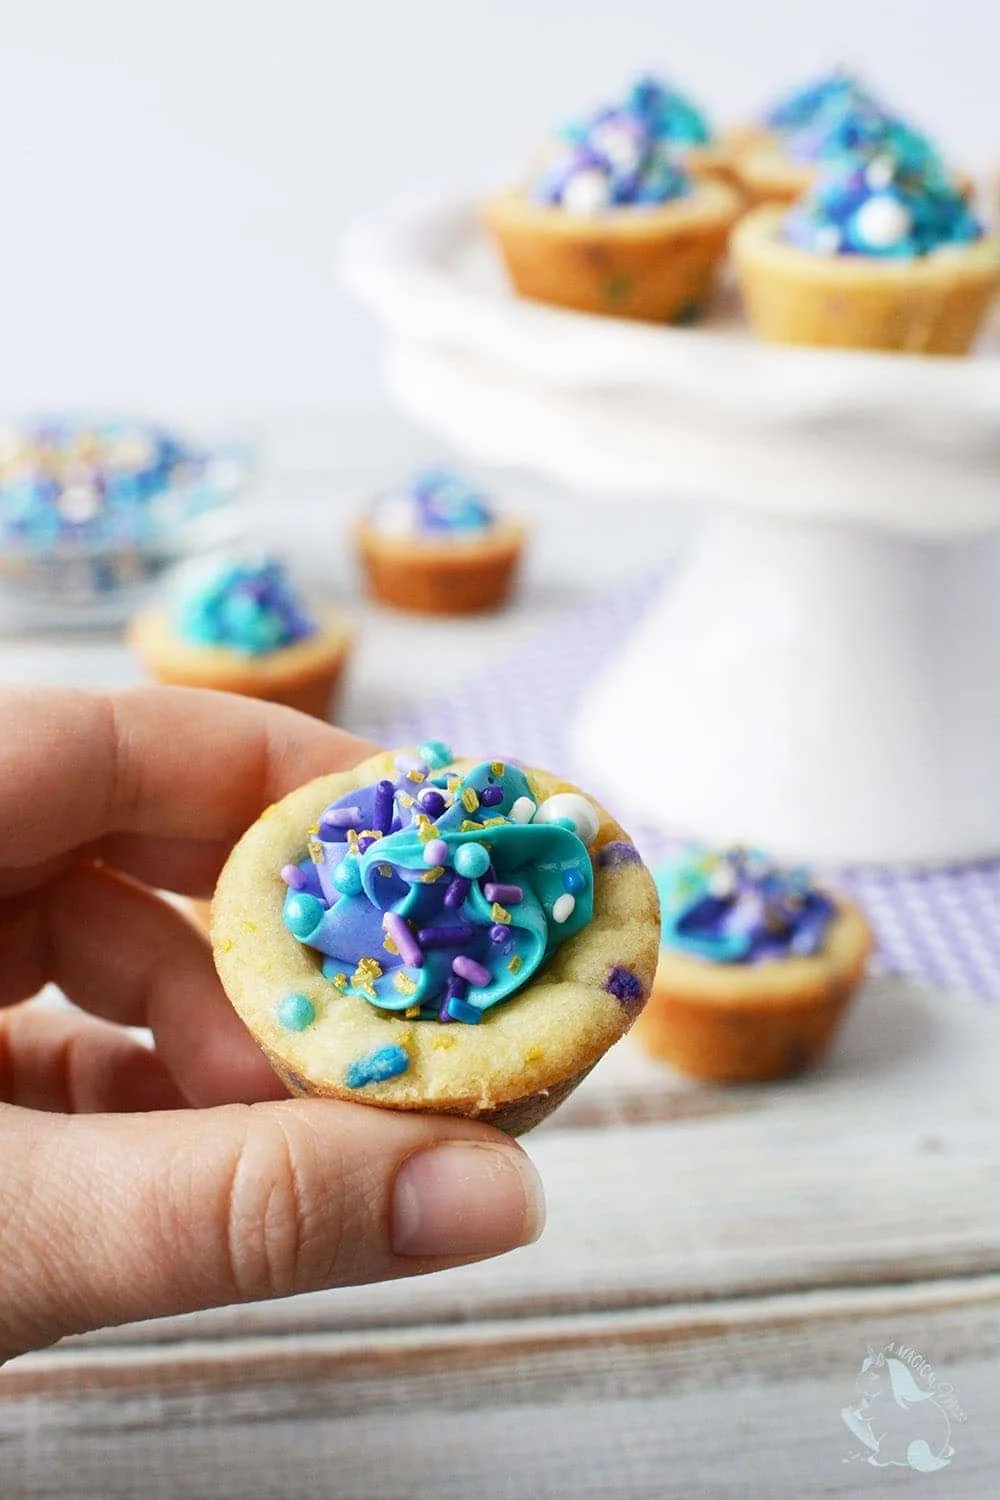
[0,687,373,869]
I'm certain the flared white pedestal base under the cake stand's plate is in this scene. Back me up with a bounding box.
[573,512,1000,864]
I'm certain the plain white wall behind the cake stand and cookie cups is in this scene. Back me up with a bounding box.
[0,0,1000,417]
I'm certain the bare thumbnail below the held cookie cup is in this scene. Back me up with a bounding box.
[391,1142,546,1257]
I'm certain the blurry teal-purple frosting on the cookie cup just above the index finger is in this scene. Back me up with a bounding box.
[172,558,318,657]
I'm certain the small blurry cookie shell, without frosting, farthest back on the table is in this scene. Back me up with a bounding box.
[354,521,525,615]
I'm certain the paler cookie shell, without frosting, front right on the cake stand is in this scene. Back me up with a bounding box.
[732,206,1000,354]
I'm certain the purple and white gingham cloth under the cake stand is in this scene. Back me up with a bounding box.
[358,578,1000,999]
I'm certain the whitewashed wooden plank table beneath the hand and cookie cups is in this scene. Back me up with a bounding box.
[0,420,1000,1500]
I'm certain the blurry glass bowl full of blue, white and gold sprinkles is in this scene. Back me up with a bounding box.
[0,417,250,627]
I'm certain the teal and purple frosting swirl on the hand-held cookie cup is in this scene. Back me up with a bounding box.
[282,741,594,1023]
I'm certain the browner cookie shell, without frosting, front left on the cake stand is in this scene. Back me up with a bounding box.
[483,182,741,323]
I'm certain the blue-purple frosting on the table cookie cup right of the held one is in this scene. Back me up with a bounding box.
[654,849,837,963]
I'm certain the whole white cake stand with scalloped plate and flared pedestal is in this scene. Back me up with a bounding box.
[345,203,1000,864]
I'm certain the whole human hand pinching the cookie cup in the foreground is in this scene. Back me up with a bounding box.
[0,689,544,1364]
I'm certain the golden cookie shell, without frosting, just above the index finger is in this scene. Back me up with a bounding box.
[127,608,354,719]
